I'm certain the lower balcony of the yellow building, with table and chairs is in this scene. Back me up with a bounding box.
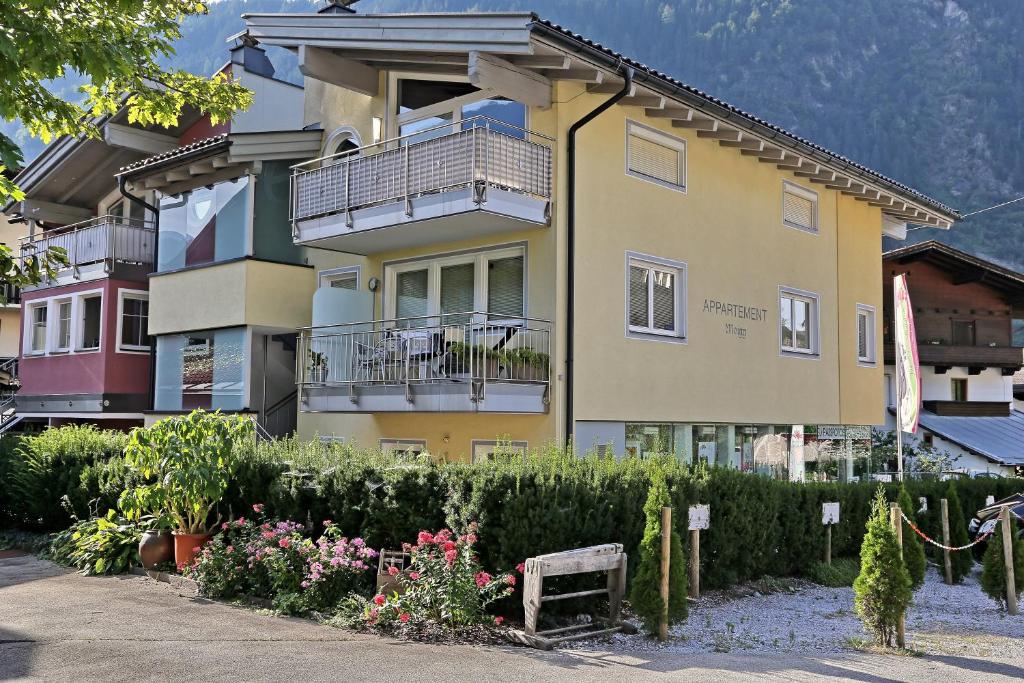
[296,312,551,414]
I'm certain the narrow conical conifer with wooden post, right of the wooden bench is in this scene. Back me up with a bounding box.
[630,469,687,635]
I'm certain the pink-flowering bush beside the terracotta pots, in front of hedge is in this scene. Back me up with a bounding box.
[184,504,377,612]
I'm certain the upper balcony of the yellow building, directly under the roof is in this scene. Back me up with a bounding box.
[292,117,552,254]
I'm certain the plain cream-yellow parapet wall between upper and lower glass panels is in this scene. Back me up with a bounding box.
[150,259,316,335]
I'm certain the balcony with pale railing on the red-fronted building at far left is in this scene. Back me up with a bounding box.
[22,216,157,288]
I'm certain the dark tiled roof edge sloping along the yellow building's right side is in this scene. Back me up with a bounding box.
[534,14,961,218]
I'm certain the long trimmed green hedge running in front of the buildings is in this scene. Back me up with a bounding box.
[0,427,1024,587]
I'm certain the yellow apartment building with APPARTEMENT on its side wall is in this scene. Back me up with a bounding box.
[151,6,957,478]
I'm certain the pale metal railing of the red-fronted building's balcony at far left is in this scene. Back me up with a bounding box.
[22,216,157,271]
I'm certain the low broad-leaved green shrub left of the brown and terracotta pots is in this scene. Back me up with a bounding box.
[49,510,142,574]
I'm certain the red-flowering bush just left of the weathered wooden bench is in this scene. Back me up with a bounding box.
[364,525,516,629]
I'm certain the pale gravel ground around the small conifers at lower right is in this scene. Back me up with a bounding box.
[580,568,1024,658]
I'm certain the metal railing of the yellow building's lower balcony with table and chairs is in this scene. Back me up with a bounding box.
[296,312,551,395]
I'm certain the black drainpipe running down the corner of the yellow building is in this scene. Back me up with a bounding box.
[565,67,633,446]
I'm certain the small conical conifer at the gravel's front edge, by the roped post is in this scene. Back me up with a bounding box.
[853,486,913,647]
